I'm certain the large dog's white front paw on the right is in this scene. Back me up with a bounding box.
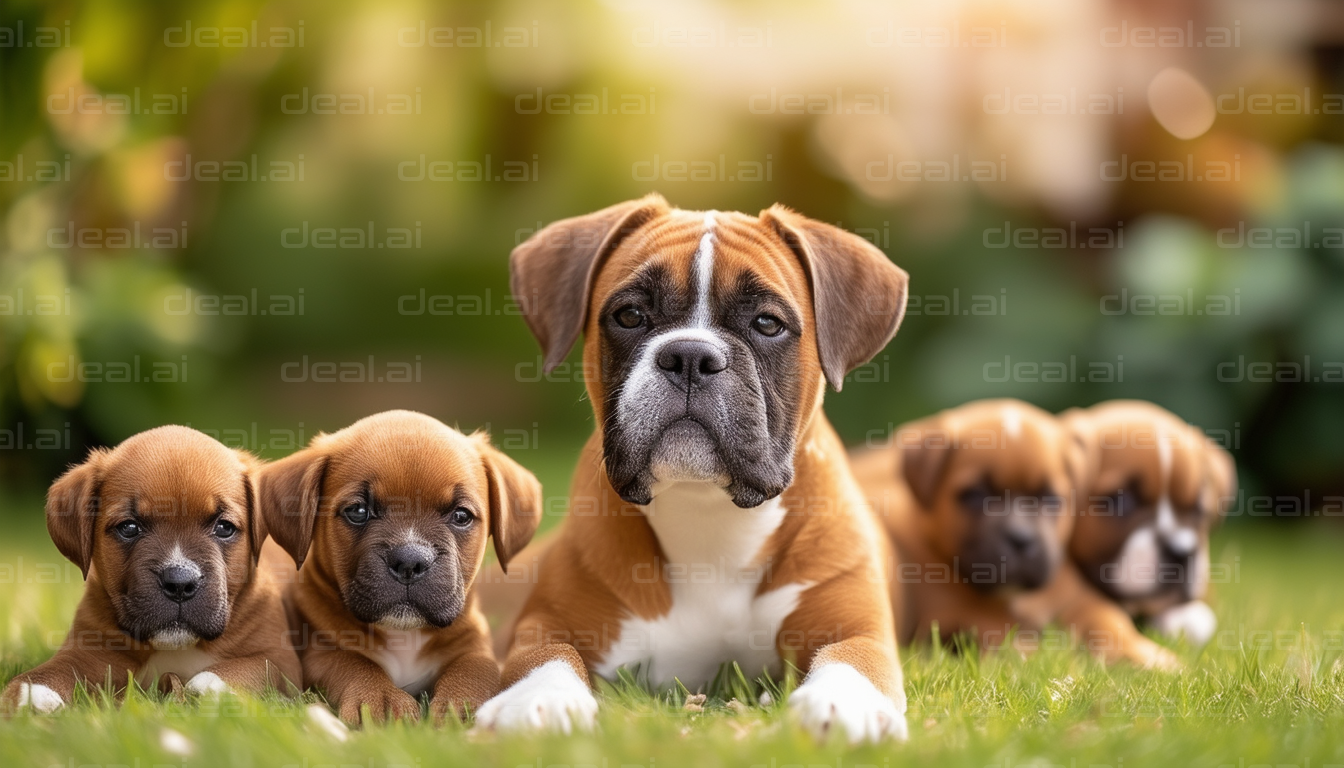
[789,663,910,744]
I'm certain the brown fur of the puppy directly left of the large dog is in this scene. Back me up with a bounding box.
[259,412,540,722]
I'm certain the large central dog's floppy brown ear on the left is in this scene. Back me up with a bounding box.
[508,194,668,373]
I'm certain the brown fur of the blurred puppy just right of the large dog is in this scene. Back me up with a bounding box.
[852,401,1176,667]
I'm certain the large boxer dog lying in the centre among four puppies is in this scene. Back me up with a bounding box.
[477,195,906,740]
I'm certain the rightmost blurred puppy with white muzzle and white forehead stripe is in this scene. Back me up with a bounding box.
[1062,401,1236,646]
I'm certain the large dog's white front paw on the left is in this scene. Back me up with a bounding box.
[476,660,597,733]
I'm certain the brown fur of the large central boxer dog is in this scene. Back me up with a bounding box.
[503,195,906,701]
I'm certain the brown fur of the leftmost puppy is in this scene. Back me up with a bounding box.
[3,426,301,712]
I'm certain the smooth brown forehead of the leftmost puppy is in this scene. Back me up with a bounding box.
[101,426,247,518]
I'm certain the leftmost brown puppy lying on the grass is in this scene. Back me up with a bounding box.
[0,426,301,713]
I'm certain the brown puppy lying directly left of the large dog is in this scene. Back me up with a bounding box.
[258,410,542,724]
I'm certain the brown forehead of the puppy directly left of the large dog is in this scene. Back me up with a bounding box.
[319,414,487,515]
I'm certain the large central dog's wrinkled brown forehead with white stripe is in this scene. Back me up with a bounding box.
[589,210,810,327]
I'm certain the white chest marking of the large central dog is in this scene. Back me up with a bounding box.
[595,483,809,690]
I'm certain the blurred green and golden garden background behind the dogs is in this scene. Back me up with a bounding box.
[0,0,1344,522]
